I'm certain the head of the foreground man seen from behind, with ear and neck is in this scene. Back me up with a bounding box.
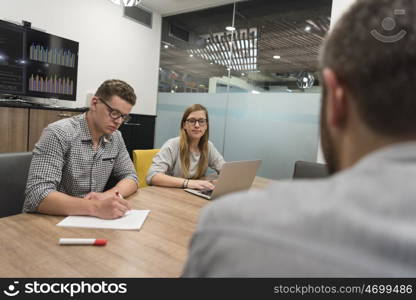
[320,0,416,173]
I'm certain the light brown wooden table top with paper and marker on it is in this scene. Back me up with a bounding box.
[0,177,270,277]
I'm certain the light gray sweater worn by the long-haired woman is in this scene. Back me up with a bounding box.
[146,137,225,184]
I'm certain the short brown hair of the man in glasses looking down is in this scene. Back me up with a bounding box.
[95,79,136,105]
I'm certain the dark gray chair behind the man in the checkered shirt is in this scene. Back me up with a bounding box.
[0,152,32,218]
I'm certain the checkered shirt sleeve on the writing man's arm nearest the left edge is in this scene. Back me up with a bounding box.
[23,127,65,212]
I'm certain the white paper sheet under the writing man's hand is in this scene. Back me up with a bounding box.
[56,210,150,230]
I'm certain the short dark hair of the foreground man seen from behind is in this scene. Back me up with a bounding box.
[321,0,416,136]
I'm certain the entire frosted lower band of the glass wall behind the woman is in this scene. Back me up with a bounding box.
[155,93,320,179]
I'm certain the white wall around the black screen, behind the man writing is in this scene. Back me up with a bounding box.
[0,0,161,115]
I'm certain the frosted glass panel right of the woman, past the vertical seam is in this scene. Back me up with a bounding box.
[224,93,320,179]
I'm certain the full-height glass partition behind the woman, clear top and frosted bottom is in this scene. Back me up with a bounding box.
[155,0,332,179]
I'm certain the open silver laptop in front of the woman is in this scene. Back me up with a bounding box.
[185,160,261,200]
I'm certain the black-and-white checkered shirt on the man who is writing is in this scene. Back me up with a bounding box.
[23,113,138,212]
